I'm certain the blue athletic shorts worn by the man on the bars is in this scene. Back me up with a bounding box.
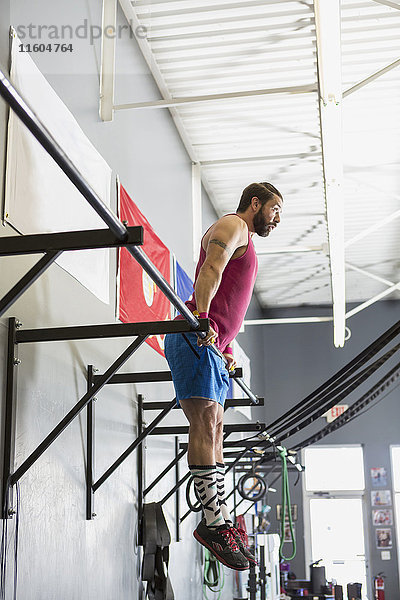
[164,333,229,406]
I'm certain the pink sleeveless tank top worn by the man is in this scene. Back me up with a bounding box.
[186,213,258,352]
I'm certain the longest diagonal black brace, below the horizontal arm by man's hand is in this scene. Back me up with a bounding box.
[10,335,147,489]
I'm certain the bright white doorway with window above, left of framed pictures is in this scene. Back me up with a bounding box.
[304,445,371,600]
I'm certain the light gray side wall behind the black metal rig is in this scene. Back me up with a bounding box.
[0,0,225,600]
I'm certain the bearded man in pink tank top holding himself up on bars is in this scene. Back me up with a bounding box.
[165,183,283,571]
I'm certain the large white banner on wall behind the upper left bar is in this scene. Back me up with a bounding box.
[3,35,112,303]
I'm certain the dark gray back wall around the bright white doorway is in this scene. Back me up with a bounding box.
[264,301,400,598]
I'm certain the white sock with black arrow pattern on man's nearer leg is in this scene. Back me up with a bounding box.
[189,465,225,527]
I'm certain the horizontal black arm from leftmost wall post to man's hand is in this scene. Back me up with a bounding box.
[17,319,208,344]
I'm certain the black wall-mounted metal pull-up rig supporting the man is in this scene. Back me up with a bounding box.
[0,71,258,524]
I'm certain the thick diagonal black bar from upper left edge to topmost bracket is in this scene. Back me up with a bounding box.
[0,71,128,240]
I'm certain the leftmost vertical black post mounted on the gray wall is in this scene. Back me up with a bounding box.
[2,317,18,519]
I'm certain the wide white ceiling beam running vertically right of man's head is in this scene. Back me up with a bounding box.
[314,0,346,348]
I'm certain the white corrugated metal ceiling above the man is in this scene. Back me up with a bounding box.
[124,0,400,314]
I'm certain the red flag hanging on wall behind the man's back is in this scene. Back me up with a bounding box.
[118,184,171,356]
